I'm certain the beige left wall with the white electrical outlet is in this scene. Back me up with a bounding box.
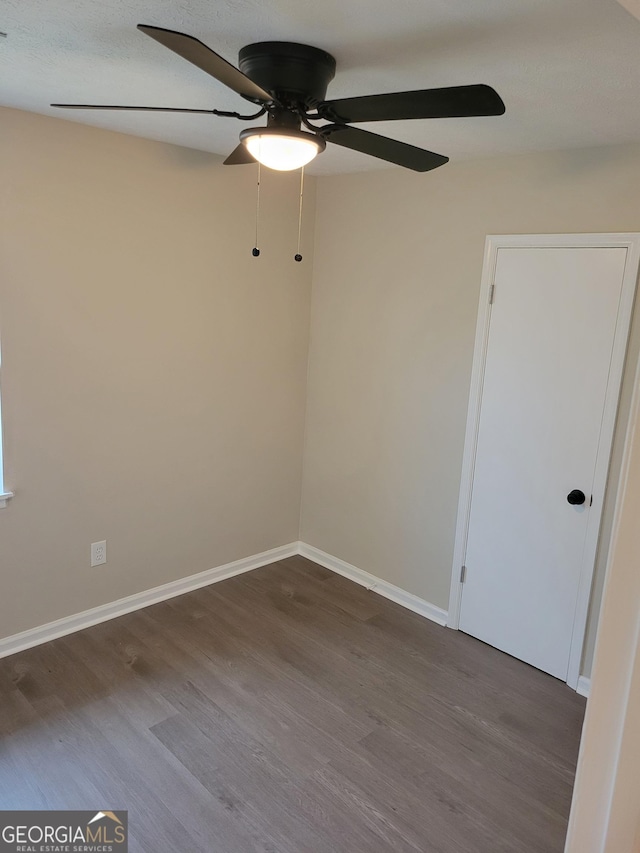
[0,110,314,637]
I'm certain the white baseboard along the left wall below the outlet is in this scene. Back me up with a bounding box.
[0,542,298,658]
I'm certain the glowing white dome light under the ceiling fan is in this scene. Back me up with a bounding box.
[240,127,326,172]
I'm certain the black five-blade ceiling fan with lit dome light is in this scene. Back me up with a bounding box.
[51,24,505,172]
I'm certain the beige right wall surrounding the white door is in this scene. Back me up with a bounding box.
[301,146,640,672]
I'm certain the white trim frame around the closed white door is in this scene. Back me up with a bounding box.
[447,233,640,690]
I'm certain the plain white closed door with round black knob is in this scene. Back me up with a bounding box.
[460,247,627,680]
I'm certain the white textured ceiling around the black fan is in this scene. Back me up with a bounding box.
[0,0,640,174]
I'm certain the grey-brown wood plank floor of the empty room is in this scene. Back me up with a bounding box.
[0,557,584,853]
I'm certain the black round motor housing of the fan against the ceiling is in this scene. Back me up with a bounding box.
[238,41,336,109]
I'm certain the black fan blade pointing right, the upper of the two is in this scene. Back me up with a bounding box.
[318,83,505,122]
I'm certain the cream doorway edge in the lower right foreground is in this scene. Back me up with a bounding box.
[566,356,640,853]
